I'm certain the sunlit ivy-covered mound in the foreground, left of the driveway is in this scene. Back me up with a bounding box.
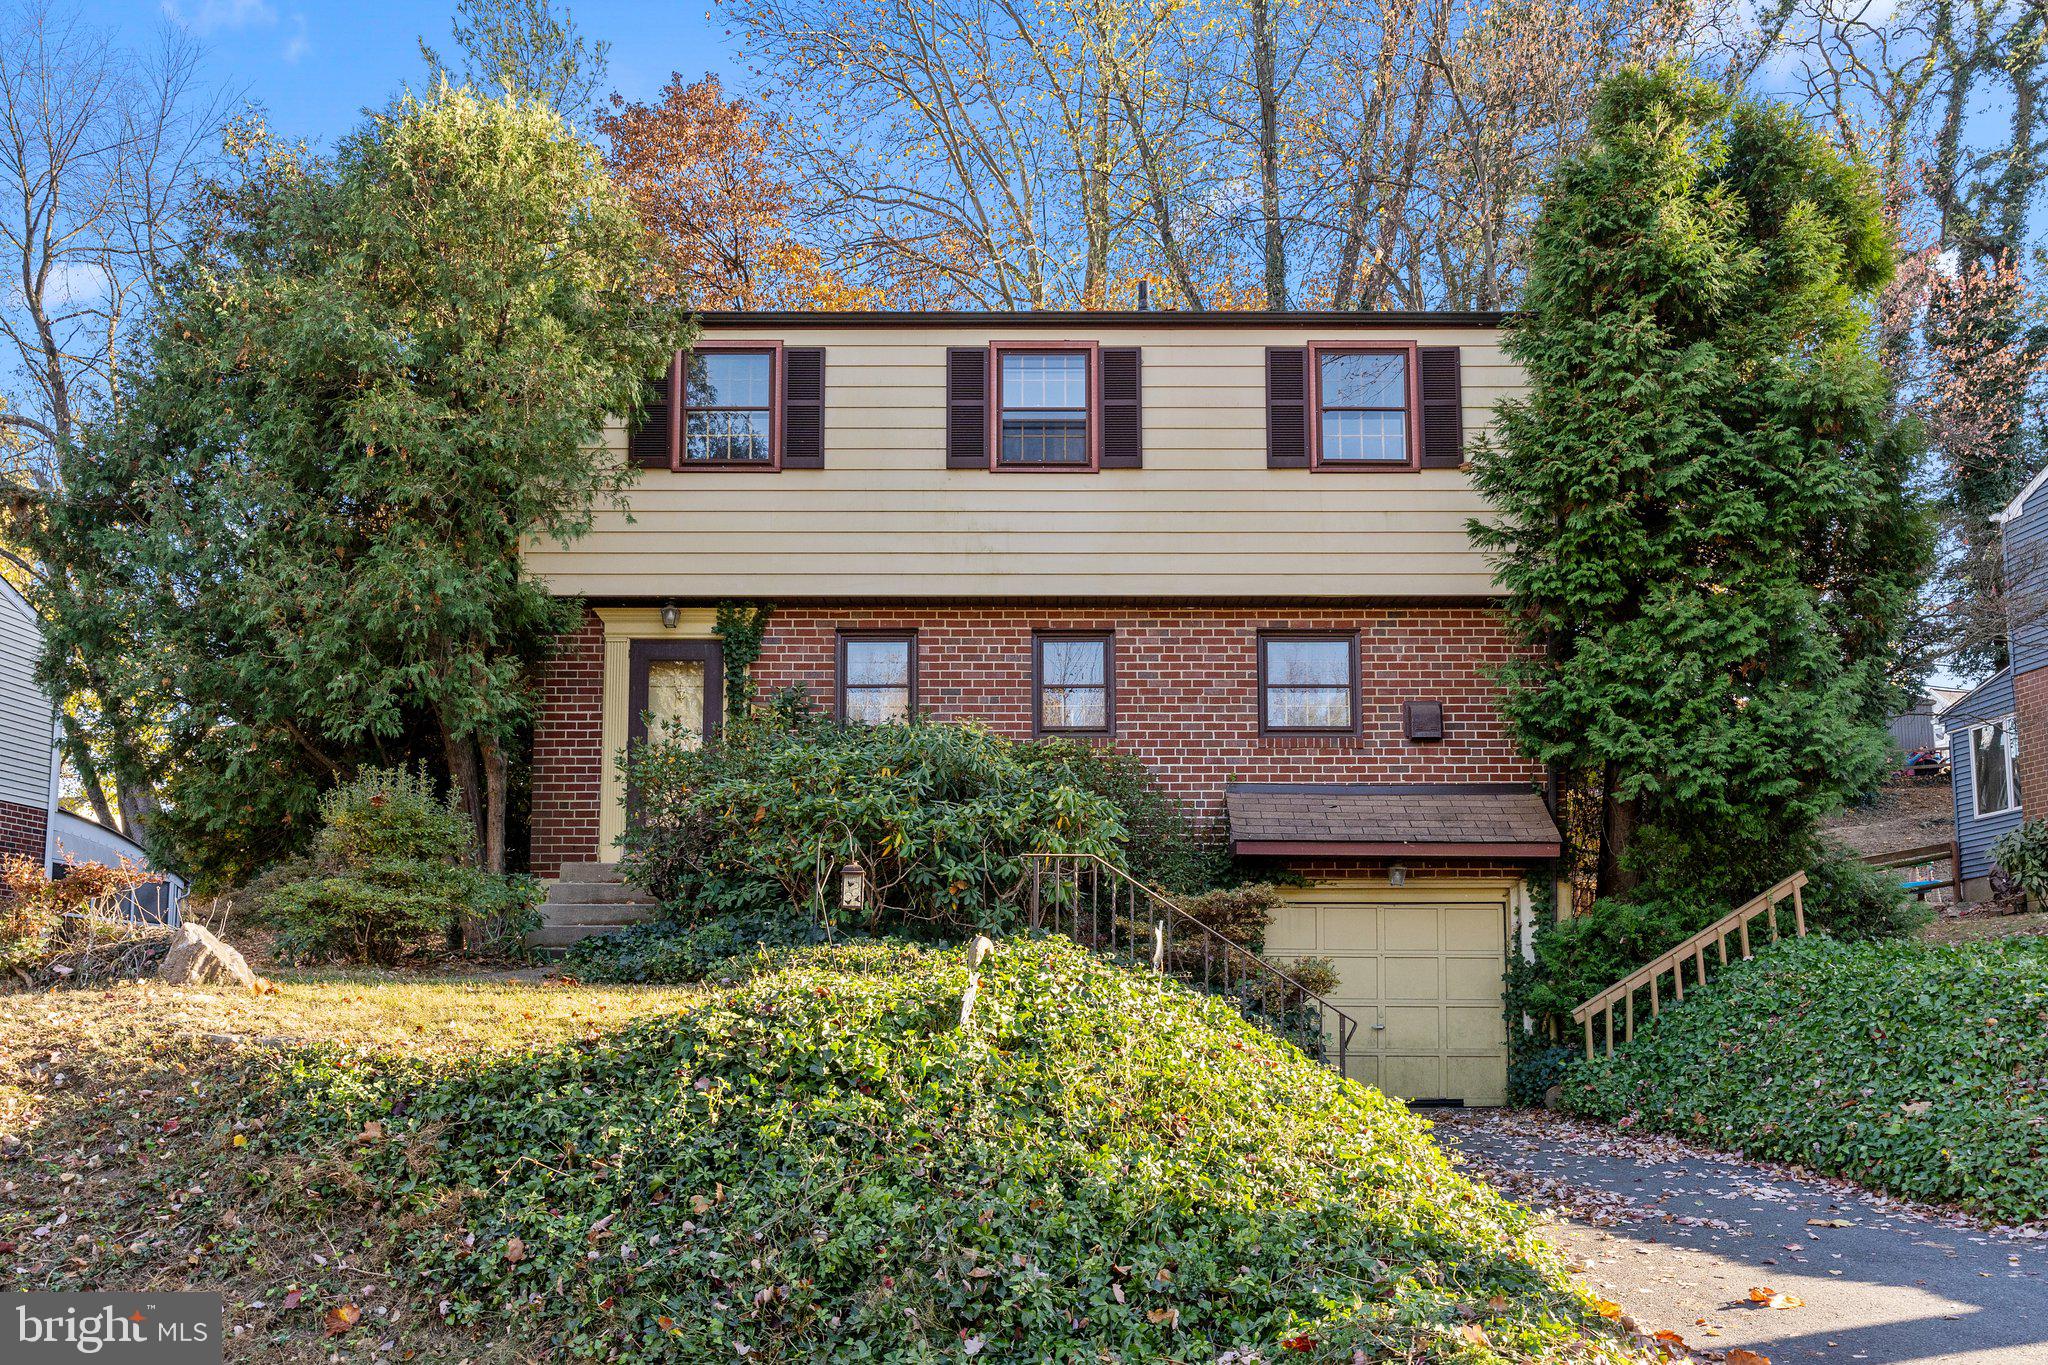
[250,939,1646,1365]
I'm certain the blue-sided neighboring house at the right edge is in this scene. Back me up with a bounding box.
[1942,469,2048,900]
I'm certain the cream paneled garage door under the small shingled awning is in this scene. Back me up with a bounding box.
[1266,886,1507,1105]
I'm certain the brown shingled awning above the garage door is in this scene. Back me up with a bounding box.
[1225,782,1559,857]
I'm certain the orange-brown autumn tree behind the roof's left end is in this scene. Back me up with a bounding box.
[594,76,868,309]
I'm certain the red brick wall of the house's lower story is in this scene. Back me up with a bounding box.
[532,604,1542,876]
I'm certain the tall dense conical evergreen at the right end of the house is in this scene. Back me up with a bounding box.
[1473,68,1929,912]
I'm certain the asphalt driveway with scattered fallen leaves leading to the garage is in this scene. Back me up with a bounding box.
[1430,1109,2048,1365]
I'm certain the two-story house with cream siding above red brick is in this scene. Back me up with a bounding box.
[528,313,1559,1103]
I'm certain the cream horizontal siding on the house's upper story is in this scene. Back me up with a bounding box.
[526,321,1520,600]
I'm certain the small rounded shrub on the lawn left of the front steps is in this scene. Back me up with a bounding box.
[250,767,541,966]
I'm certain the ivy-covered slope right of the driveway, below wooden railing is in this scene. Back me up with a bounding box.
[1565,937,2048,1220]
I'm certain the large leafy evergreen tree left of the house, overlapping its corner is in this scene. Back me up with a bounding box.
[16,84,686,880]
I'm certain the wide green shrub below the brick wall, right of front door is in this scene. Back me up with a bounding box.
[625,714,1124,933]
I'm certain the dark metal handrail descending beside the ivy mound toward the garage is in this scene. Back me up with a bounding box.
[1024,853,1358,1074]
